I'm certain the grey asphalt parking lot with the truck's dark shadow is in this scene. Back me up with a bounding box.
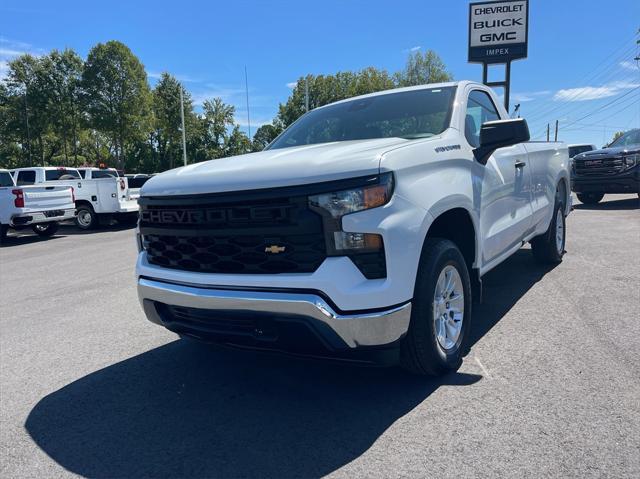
[0,195,640,478]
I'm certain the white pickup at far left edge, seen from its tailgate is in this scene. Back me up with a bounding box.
[0,170,75,242]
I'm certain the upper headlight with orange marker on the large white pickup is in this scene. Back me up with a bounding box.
[309,173,393,219]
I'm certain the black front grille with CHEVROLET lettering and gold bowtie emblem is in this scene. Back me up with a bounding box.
[140,196,326,274]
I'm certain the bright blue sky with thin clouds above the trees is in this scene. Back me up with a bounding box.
[0,0,640,145]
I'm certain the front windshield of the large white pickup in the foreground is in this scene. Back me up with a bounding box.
[268,87,455,149]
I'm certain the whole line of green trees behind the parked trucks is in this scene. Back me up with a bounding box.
[0,41,451,173]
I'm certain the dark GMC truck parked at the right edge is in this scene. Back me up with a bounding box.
[571,129,640,205]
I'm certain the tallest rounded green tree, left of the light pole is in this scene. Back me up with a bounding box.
[82,40,151,168]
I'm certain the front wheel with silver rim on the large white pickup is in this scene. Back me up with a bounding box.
[400,238,472,376]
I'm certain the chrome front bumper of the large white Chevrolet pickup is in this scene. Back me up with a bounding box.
[138,277,411,352]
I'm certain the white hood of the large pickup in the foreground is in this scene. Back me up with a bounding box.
[140,138,411,196]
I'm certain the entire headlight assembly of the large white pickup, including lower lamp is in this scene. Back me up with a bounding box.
[309,173,393,256]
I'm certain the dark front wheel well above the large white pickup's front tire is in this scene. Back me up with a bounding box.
[427,208,476,271]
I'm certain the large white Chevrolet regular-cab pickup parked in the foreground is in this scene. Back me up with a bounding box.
[137,81,571,374]
